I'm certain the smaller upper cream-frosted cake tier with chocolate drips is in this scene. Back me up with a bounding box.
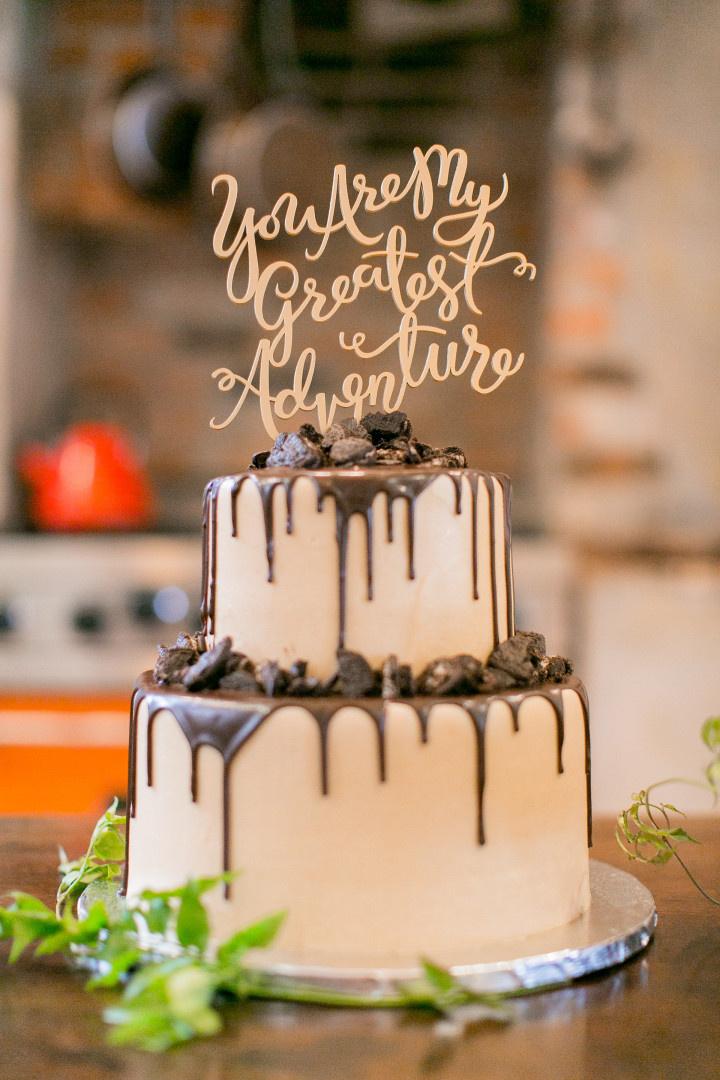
[203,467,515,678]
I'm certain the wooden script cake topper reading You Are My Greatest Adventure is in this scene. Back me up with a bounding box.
[210,145,535,438]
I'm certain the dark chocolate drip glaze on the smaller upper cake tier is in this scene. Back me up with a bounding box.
[202,468,513,648]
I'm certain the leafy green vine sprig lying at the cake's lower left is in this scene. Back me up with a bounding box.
[0,799,512,1051]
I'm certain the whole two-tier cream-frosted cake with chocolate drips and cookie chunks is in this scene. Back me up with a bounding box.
[126,414,590,964]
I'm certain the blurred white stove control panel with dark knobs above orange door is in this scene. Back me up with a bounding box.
[0,535,200,693]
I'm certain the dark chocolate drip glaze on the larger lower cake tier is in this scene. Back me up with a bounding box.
[125,673,592,896]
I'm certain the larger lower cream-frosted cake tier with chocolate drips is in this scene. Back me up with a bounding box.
[126,675,589,963]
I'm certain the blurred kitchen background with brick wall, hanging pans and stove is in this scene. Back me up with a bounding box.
[0,0,720,813]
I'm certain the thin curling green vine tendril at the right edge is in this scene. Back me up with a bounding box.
[615,716,720,907]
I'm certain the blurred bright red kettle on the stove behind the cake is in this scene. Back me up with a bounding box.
[18,423,152,531]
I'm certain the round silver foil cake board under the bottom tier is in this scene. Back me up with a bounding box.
[78,860,657,1005]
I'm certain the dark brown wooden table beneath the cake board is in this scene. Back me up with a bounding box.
[0,818,720,1080]
